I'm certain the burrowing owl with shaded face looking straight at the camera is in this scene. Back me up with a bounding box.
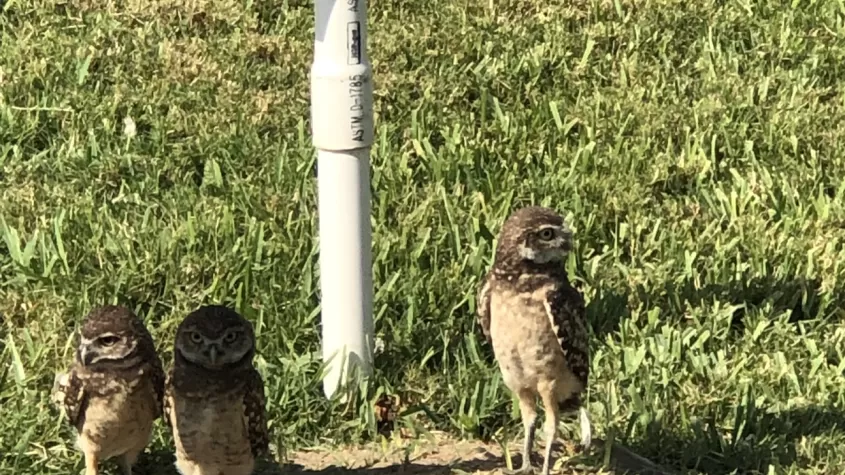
[164,305,268,475]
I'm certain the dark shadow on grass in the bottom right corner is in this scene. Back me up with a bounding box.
[630,407,845,475]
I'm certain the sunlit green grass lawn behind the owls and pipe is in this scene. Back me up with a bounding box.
[0,0,845,474]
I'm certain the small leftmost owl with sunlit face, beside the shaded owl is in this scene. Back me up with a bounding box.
[52,306,164,475]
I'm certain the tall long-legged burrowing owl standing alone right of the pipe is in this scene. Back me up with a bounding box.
[477,206,591,475]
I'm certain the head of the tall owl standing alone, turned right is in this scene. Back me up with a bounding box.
[496,206,572,264]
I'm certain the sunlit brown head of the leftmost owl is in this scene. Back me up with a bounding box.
[76,305,154,368]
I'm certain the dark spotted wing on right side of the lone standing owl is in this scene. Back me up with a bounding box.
[543,283,590,386]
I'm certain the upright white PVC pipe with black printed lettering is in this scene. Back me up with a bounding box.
[311,0,373,397]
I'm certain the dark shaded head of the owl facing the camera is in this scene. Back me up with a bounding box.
[174,305,255,370]
